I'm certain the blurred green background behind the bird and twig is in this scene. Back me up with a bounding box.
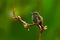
[0,0,60,40]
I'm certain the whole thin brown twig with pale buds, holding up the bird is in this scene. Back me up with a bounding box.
[13,8,47,40]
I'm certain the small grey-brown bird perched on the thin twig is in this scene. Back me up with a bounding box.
[32,12,43,25]
